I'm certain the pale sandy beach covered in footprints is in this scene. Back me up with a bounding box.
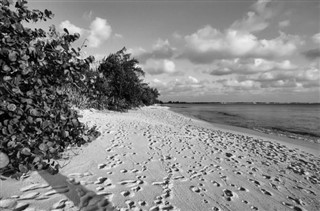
[0,106,320,211]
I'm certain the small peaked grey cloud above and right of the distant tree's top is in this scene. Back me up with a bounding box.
[136,39,175,63]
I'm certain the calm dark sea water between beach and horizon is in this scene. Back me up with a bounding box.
[166,104,320,143]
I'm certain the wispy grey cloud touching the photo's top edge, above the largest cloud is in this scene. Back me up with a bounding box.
[231,0,273,32]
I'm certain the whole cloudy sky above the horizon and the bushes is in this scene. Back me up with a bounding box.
[28,0,320,102]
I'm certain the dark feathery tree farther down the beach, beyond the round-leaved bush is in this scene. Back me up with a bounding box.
[95,48,159,110]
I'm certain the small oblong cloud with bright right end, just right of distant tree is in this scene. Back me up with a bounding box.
[142,59,176,75]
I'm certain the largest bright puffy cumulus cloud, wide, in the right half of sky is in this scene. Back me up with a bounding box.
[179,25,302,64]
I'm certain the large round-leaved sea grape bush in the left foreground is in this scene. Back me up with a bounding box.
[0,0,98,174]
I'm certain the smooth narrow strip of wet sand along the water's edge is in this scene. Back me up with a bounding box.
[162,106,320,156]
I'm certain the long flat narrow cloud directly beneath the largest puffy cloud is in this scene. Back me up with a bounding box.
[208,58,297,75]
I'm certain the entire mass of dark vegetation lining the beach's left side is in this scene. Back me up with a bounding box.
[0,0,159,177]
